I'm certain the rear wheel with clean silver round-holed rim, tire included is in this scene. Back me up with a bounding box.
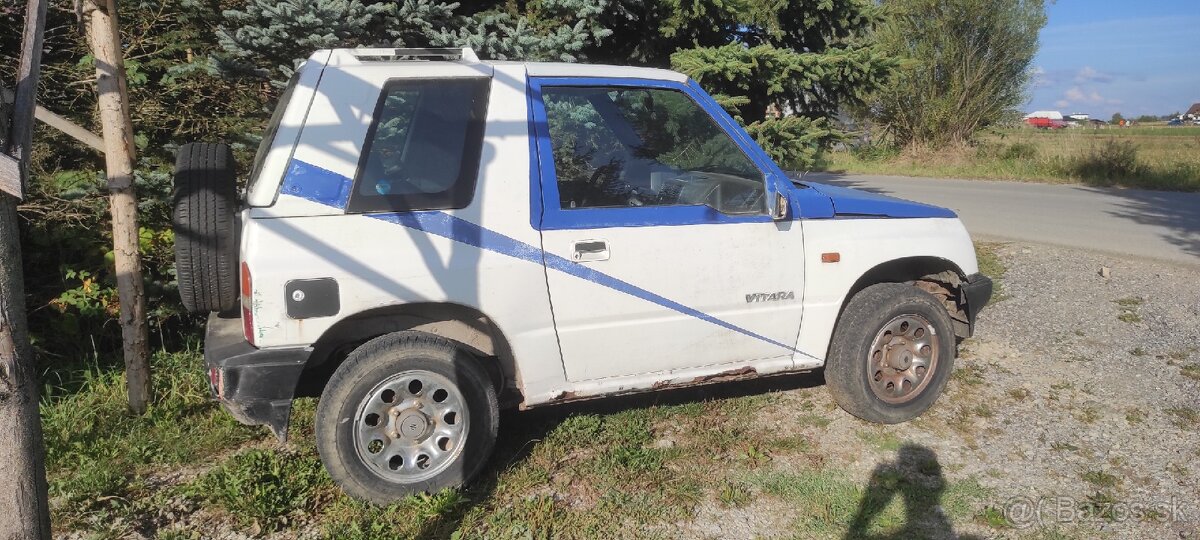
[316,331,499,504]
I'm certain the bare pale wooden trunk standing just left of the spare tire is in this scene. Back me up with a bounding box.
[84,0,150,414]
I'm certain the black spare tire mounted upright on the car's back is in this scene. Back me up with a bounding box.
[172,143,239,313]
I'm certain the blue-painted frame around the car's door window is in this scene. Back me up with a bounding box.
[527,77,799,230]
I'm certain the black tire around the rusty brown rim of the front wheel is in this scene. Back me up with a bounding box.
[824,283,956,424]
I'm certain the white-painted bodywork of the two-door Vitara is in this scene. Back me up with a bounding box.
[241,52,977,406]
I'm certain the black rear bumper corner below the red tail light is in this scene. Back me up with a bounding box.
[204,313,312,440]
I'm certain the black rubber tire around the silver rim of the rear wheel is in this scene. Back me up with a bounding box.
[316,331,499,504]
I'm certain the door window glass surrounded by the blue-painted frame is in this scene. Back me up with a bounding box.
[542,86,766,214]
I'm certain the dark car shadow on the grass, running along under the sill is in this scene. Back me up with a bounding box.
[416,371,824,539]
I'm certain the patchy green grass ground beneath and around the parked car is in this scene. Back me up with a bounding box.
[43,352,985,540]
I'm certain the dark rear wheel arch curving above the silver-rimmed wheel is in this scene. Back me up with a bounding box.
[296,302,522,404]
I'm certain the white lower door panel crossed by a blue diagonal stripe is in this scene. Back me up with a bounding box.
[542,222,804,382]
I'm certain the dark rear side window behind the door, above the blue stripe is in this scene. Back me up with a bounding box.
[347,79,490,212]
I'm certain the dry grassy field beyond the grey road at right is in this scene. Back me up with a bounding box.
[818,125,1200,191]
